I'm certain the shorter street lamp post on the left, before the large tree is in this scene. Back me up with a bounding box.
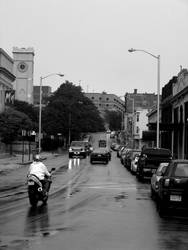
[38,73,64,154]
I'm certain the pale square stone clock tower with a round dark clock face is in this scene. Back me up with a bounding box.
[13,47,34,104]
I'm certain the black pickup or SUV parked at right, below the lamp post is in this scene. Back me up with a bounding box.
[136,147,172,180]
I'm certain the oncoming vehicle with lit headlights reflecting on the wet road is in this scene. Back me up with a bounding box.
[69,141,88,158]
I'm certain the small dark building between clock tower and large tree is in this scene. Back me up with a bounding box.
[33,86,52,106]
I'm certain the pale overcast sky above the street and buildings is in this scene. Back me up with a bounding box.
[0,0,188,96]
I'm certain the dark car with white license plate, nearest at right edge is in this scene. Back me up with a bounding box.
[157,159,188,214]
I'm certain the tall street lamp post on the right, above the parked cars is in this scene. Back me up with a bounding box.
[128,48,160,148]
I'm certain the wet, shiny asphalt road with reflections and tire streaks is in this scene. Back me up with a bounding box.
[0,141,188,250]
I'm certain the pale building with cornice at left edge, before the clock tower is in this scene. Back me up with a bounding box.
[0,48,15,112]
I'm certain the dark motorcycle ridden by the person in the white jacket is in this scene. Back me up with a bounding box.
[27,168,55,207]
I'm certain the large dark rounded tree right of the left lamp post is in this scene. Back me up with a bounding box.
[42,81,104,145]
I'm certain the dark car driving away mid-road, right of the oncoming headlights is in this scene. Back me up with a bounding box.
[90,148,109,164]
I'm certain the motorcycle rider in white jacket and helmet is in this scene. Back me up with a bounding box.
[27,154,51,192]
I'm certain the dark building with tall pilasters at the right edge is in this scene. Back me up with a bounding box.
[160,69,188,159]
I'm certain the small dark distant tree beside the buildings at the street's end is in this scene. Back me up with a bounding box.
[105,110,122,131]
